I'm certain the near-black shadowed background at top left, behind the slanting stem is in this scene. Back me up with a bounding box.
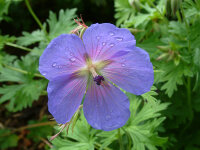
[0,0,115,36]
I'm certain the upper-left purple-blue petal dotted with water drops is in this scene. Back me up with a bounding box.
[39,34,86,80]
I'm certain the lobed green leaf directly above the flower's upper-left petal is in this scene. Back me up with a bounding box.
[17,9,76,47]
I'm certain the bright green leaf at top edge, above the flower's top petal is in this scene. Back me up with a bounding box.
[115,0,165,28]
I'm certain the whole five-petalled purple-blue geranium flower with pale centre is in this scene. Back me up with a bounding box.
[39,23,154,131]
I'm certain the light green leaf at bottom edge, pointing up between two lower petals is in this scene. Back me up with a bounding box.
[52,112,97,150]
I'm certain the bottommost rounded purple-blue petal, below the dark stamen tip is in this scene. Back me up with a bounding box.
[83,82,130,131]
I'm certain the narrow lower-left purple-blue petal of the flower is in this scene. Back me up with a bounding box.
[47,75,87,124]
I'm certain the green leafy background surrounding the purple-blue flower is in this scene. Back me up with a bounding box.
[0,0,200,150]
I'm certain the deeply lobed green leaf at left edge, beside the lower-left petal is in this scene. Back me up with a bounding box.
[0,55,47,112]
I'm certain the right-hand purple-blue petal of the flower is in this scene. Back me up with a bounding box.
[102,47,154,95]
